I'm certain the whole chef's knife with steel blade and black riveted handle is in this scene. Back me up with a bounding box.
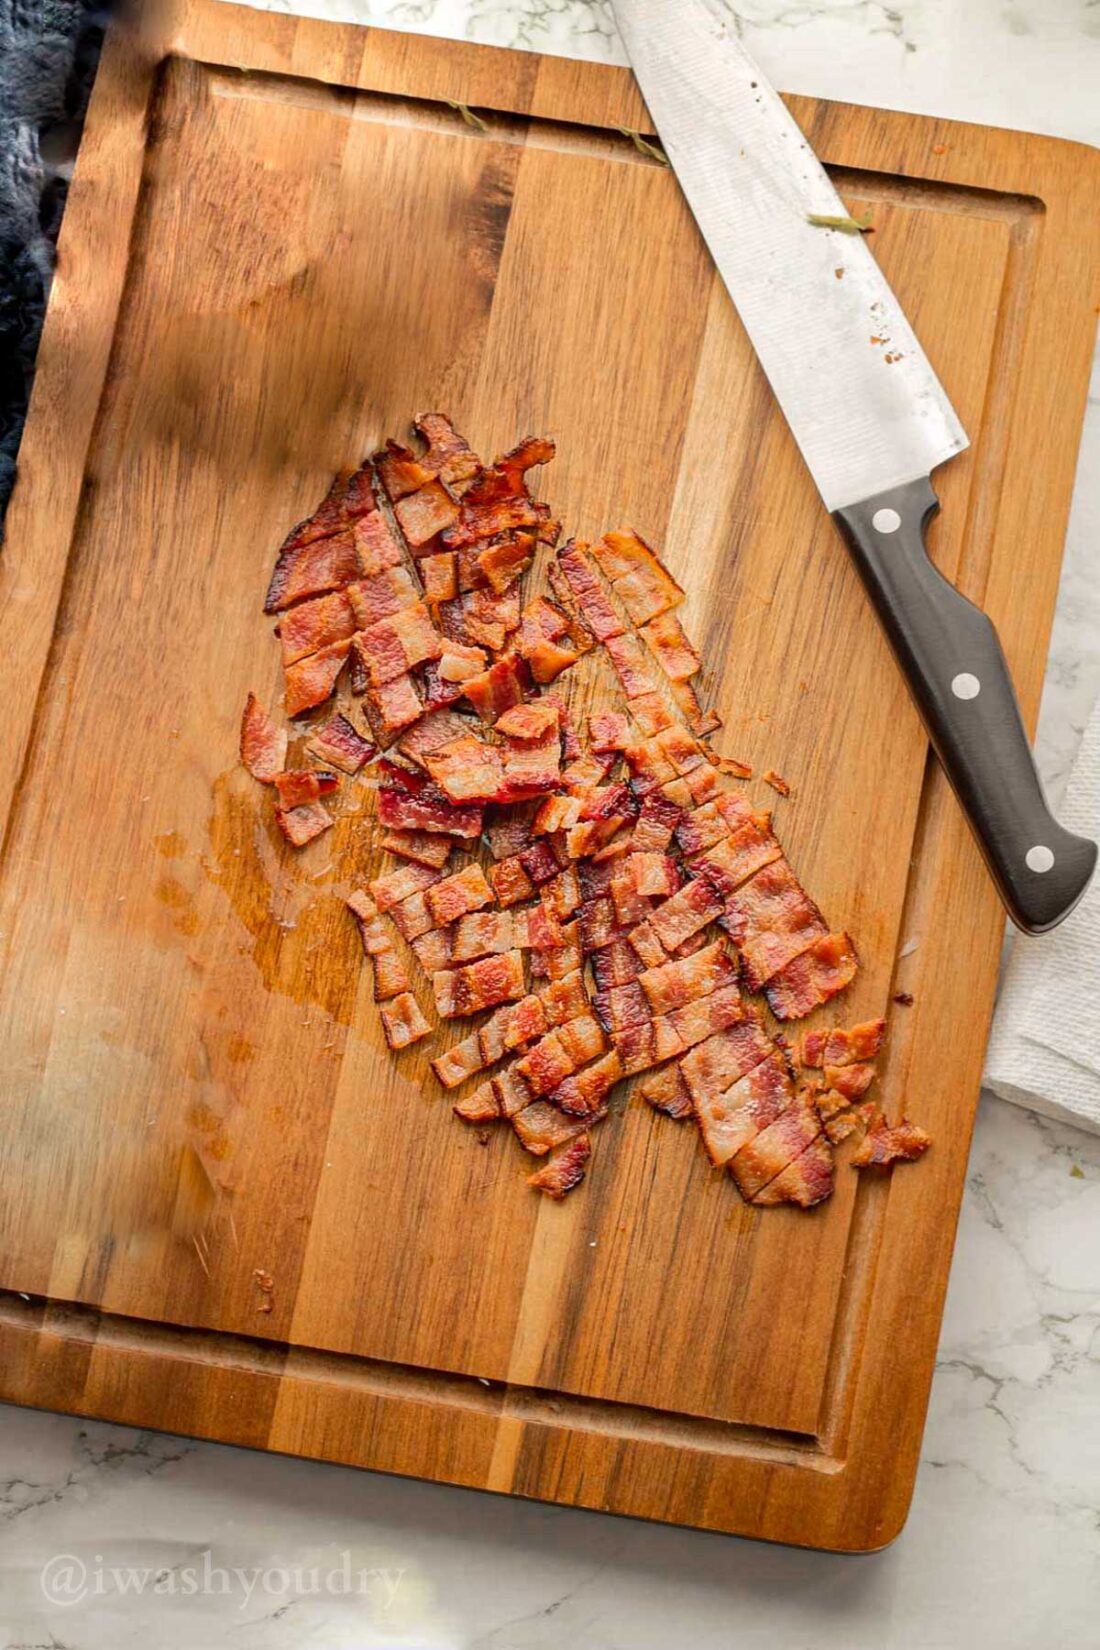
[612,0,1097,934]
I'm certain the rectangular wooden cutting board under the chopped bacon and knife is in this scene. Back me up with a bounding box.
[0,0,1100,1549]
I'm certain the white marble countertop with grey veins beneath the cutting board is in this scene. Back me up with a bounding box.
[0,0,1100,1650]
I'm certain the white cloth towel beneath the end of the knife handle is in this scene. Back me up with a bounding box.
[985,701,1100,1134]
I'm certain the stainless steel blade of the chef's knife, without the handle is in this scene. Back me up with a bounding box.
[612,0,968,510]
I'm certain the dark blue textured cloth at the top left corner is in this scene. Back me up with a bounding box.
[0,0,107,520]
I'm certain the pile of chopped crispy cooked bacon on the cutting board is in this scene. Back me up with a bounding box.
[241,412,928,1208]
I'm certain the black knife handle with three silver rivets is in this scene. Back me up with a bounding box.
[833,479,1097,934]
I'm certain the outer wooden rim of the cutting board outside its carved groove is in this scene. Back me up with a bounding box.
[0,0,1100,1551]
